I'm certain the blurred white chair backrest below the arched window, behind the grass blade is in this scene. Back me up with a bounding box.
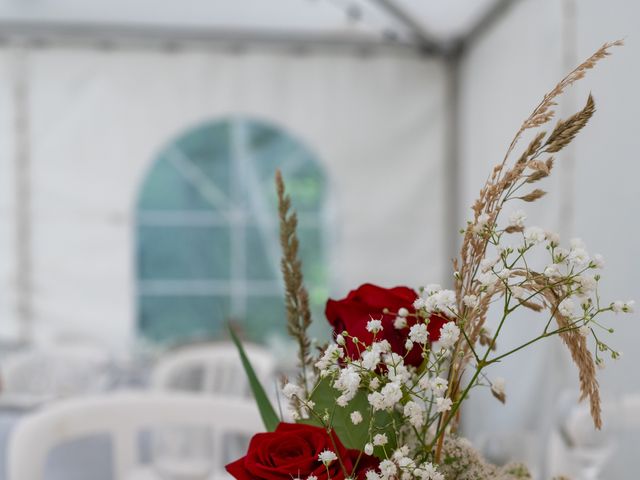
[152,342,276,396]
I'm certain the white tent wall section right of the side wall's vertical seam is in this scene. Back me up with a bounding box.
[574,0,640,480]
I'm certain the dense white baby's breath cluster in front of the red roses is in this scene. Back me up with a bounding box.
[296,296,461,480]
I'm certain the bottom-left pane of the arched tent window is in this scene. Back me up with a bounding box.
[138,296,229,344]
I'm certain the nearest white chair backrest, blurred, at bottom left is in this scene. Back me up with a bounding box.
[8,392,263,480]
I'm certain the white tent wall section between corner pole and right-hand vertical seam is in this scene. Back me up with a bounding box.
[461,1,573,478]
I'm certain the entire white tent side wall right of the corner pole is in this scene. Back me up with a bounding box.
[461,0,640,479]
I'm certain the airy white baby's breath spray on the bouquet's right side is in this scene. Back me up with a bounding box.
[472,210,634,365]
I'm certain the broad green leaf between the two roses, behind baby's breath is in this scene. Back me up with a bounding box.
[301,378,399,456]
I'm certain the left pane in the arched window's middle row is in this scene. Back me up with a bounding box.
[137,226,230,280]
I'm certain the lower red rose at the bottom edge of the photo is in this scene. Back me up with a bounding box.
[226,423,378,480]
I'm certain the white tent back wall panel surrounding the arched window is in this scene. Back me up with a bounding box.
[1,48,446,346]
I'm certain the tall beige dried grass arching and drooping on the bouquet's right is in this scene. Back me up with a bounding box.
[450,41,622,432]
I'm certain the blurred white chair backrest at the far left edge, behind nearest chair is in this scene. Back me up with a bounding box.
[0,345,110,396]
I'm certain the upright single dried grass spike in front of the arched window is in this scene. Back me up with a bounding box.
[275,170,313,397]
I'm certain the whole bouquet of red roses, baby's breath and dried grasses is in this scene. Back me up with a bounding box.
[227,42,633,480]
